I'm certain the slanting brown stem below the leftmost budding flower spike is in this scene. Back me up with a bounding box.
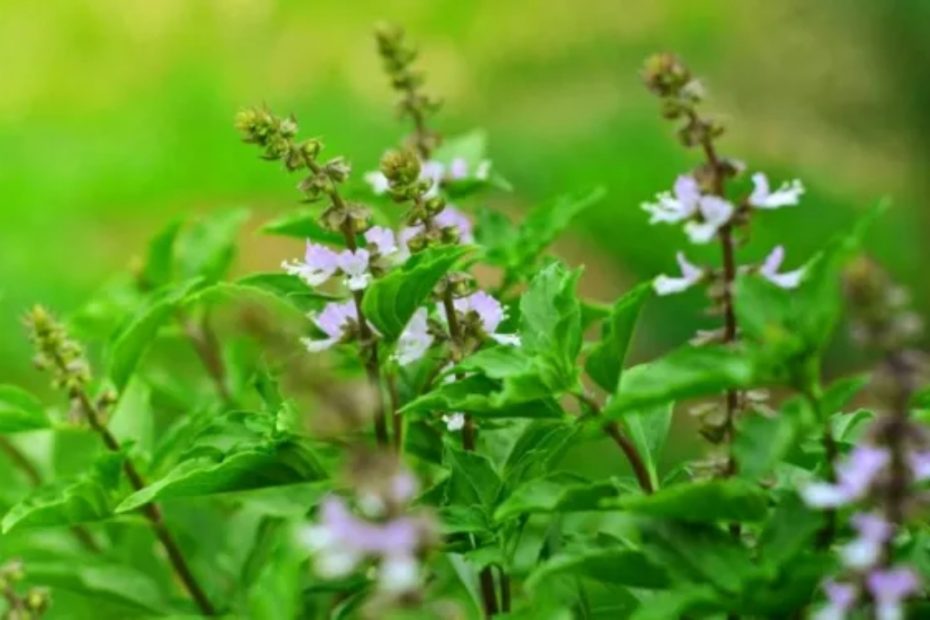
[73,391,216,616]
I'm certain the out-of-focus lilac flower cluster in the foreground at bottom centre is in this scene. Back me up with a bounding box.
[301,455,436,597]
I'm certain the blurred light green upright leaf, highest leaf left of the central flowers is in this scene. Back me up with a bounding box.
[176,209,249,282]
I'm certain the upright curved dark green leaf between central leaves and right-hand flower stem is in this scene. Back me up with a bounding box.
[585,282,652,394]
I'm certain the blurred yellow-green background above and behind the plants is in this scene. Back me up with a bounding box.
[0,0,930,383]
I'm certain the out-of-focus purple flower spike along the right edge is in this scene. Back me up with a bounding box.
[801,261,930,620]
